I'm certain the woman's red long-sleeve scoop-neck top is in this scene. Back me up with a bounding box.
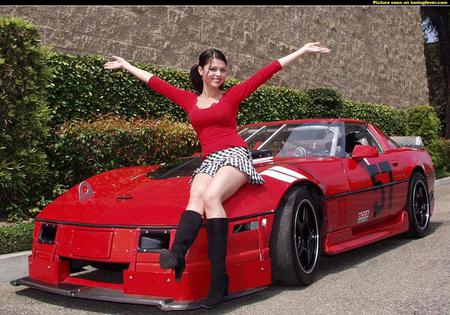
[147,60,282,157]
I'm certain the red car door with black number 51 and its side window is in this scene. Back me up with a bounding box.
[342,122,404,227]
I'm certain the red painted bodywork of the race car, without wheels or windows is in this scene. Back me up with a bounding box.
[14,119,434,309]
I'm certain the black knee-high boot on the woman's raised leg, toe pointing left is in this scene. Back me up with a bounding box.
[159,210,203,281]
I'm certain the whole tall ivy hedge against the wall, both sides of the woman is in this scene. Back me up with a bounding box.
[43,53,412,134]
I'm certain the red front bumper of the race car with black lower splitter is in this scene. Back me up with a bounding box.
[12,214,273,310]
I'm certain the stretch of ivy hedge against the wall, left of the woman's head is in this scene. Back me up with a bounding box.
[46,52,190,126]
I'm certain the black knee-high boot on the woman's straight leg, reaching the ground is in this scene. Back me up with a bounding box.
[200,218,228,308]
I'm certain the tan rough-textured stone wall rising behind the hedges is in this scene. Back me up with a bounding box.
[0,6,428,107]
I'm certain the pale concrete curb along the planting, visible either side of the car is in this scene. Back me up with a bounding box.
[0,177,450,283]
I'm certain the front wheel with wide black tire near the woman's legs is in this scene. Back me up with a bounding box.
[270,186,320,286]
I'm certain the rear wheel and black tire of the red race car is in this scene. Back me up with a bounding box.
[406,172,430,238]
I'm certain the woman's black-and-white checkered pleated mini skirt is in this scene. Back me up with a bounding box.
[189,147,265,184]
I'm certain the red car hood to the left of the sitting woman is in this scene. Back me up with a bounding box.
[37,167,189,226]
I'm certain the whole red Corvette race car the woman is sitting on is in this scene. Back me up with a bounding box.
[13,119,435,310]
